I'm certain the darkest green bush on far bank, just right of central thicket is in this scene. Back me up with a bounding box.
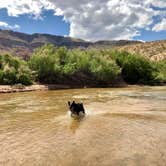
[112,52,156,84]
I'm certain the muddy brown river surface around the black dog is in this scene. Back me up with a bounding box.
[0,87,166,166]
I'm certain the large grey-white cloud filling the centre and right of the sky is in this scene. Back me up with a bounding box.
[50,0,166,40]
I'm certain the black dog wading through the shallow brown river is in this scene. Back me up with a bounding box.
[68,101,85,115]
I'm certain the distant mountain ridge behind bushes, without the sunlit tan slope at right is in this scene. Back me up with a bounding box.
[0,30,141,59]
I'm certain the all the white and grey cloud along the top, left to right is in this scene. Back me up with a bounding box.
[0,0,166,40]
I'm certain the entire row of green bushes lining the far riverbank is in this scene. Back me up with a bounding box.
[0,45,166,85]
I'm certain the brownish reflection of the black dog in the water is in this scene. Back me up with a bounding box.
[70,115,85,134]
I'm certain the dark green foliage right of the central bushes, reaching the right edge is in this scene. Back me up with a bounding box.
[112,52,166,85]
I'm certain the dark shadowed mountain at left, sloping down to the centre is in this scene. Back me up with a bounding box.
[0,30,90,59]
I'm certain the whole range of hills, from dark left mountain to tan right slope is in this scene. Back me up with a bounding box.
[0,30,166,60]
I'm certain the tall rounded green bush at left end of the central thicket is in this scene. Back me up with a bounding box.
[29,45,61,83]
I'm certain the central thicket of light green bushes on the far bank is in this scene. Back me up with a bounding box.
[29,45,120,83]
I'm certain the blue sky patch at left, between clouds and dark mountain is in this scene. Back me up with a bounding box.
[0,9,70,36]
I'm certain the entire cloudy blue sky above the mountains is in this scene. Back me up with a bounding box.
[0,0,166,41]
